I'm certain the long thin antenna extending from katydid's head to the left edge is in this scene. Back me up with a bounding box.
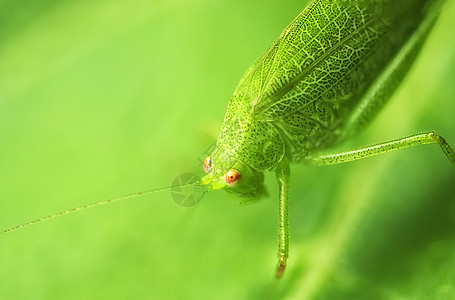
[0,182,197,235]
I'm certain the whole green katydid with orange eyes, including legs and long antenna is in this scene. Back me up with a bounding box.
[0,0,455,277]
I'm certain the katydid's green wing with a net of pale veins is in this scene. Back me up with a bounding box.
[237,0,444,128]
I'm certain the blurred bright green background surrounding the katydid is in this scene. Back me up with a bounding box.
[0,0,455,299]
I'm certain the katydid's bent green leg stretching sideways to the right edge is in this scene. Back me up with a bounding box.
[305,131,455,166]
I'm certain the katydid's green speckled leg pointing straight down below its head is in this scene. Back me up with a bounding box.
[276,159,290,278]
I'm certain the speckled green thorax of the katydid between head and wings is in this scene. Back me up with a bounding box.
[217,93,339,171]
